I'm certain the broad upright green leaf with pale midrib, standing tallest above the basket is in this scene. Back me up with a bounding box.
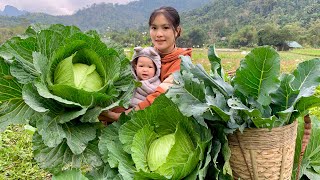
[233,47,280,106]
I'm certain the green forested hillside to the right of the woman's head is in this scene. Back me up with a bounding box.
[182,0,320,47]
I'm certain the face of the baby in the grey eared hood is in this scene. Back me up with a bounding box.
[135,57,156,80]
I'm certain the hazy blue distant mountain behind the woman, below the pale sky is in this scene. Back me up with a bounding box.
[1,0,210,32]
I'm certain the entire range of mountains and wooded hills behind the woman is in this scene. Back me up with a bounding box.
[0,0,320,47]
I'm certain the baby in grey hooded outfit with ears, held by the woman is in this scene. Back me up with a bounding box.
[130,47,161,107]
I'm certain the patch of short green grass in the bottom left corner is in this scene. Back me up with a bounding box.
[0,125,49,180]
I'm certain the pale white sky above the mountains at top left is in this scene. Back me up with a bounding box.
[0,0,136,15]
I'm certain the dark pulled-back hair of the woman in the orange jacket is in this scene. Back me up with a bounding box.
[149,6,181,38]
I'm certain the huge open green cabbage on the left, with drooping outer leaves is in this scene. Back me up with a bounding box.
[0,24,133,173]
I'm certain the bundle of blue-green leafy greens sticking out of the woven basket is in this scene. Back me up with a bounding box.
[166,46,320,179]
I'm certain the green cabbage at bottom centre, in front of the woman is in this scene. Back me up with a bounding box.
[99,95,212,179]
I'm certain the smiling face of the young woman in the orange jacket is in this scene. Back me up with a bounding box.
[150,14,177,53]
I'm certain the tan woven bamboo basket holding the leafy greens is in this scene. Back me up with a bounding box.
[228,121,298,180]
